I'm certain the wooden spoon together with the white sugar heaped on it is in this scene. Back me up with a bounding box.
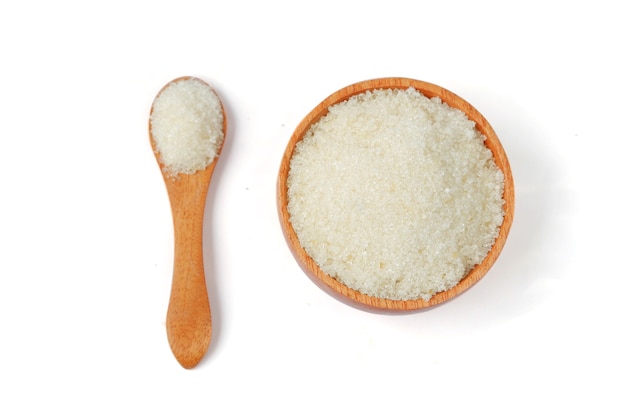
[149,76,226,369]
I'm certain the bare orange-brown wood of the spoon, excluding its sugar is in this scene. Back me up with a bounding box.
[149,77,226,369]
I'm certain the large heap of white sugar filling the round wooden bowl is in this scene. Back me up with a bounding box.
[287,88,504,300]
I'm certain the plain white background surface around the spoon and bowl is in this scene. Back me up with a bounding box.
[0,0,626,416]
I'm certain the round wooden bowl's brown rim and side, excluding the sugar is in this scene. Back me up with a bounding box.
[277,78,515,312]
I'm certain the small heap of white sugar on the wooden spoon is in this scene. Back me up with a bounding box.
[150,78,224,175]
